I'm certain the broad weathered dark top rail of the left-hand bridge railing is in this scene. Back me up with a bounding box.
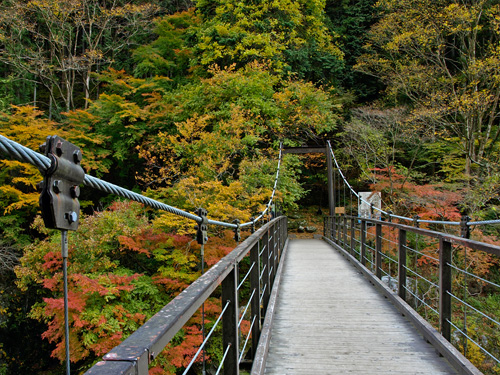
[86,216,285,375]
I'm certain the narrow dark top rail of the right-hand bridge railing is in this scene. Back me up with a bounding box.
[327,215,500,256]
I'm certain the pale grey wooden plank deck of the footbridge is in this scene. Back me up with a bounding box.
[265,239,457,375]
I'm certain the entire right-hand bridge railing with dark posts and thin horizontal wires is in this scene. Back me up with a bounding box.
[324,215,500,373]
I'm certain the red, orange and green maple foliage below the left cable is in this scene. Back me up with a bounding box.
[16,203,242,373]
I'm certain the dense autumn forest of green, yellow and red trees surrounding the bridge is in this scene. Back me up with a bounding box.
[0,0,500,375]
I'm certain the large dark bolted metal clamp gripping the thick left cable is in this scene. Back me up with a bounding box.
[39,135,85,230]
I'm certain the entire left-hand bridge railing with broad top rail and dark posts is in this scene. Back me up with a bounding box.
[86,216,287,375]
